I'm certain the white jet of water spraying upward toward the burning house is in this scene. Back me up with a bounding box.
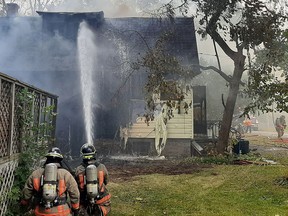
[77,22,96,143]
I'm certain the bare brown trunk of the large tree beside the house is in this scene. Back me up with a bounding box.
[217,52,245,154]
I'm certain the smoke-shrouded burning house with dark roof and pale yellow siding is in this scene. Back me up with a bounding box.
[0,8,207,155]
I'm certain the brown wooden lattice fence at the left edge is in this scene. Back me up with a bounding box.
[0,73,58,216]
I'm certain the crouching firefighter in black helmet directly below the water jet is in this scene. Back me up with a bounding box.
[75,143,111,216]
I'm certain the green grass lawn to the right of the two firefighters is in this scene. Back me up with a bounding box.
[108,134,288,216]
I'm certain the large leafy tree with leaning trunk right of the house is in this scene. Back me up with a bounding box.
[152,0,287,153]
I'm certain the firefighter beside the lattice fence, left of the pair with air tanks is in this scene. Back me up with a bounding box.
[21,147,80,216]
